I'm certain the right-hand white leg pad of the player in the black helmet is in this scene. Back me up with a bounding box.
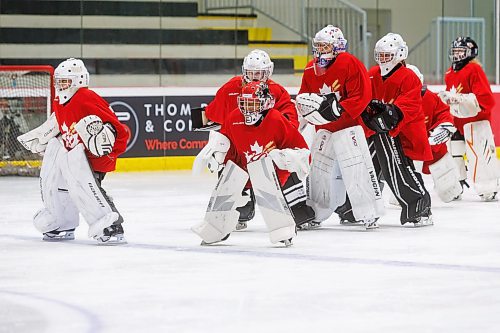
[464,120,500,195]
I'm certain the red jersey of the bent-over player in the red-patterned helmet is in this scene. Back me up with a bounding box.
[221,109,308,186]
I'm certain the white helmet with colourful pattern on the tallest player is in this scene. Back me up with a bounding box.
[312,24,347,76]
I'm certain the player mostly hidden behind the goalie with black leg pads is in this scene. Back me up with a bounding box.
[406,65,462,202]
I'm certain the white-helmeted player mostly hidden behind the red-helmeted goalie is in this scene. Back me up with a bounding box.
[194,49,299,229]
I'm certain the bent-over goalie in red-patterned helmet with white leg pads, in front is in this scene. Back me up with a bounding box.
[192,81,314,246]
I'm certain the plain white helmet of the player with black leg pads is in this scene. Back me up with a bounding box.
[374,32,408,76]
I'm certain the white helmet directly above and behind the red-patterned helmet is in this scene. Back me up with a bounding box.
[241,49,274,82]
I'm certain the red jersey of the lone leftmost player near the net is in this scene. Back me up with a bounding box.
[52,88,128,172]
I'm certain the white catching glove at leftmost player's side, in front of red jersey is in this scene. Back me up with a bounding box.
[75,115,116,157]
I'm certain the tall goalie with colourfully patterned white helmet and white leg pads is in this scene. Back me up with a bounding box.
[296,25,383,229]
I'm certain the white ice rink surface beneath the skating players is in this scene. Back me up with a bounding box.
[0,172,500,333]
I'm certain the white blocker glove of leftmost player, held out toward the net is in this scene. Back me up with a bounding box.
[17,113,59,154]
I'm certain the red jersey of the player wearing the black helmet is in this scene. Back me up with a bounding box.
[444,62,495,134]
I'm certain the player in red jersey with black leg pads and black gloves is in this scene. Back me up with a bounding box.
[363,33,432,226]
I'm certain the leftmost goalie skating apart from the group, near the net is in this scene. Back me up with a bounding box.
[18,58,127,244]
